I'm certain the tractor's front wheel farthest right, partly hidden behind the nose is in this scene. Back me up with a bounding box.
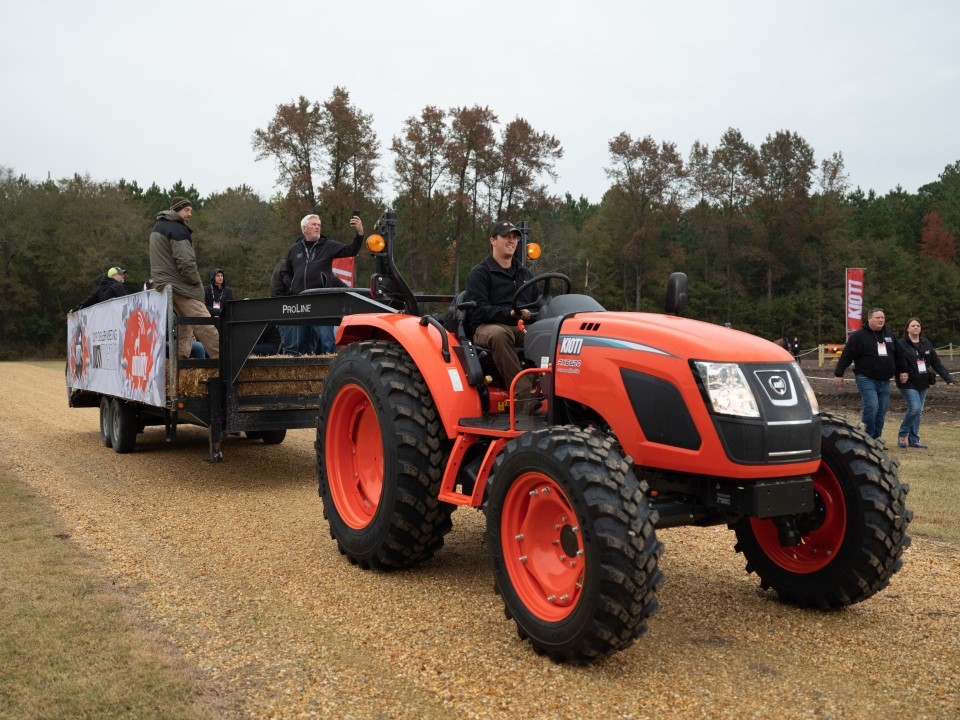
[730,413,913,610]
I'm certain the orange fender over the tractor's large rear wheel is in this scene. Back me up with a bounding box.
[337,314,483,438]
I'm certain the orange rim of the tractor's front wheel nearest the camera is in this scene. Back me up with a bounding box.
[500,472,585,622]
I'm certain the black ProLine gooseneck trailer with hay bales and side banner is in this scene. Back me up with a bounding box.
[66,287,396,462]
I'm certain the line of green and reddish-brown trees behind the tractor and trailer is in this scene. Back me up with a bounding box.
[0,87,960,359]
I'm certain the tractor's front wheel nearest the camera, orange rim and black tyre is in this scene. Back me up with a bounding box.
[486,427,663,662]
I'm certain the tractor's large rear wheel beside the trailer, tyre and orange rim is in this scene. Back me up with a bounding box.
[316,342,454,569]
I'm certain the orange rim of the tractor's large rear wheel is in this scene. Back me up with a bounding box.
[324,385,383,530]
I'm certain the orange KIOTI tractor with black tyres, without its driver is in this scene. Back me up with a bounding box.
[316,211,912,662]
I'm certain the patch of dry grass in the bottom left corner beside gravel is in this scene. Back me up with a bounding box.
[0,473,216,720]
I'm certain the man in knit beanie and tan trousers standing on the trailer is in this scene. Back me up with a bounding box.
[150,197,220,358]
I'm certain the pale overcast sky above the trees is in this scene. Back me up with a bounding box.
[0,0,960,202]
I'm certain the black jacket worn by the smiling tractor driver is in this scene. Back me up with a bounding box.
[466,255,540,337]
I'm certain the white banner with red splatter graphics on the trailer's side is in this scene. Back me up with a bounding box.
[67,290,167,407]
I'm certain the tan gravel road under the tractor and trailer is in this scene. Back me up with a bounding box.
[0,363,960,720]
